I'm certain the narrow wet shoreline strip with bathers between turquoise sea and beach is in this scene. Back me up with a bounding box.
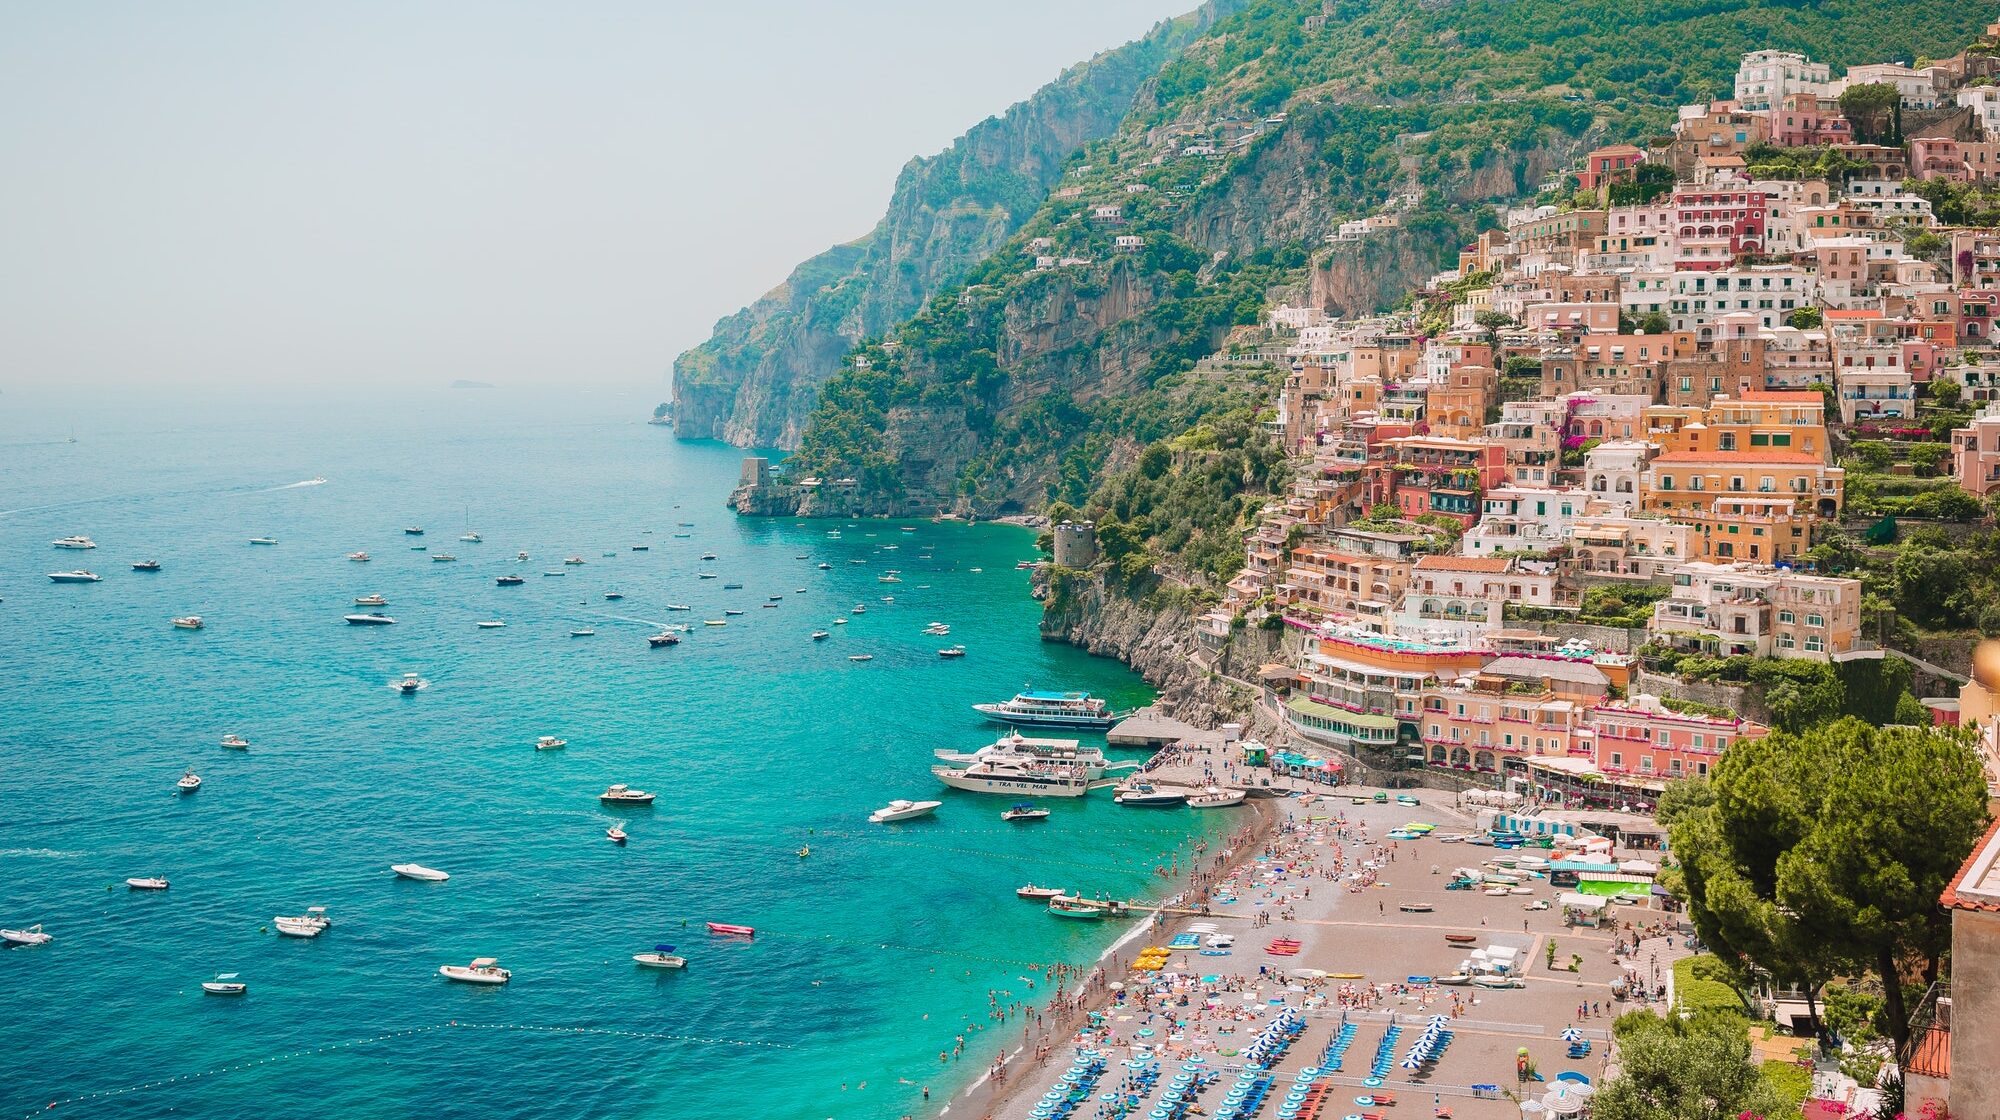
[938,790,1288,1118]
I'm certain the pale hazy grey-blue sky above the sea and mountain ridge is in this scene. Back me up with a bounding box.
[0,0,1196,396]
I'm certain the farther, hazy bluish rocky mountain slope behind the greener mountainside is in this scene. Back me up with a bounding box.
[674,0,1242,448]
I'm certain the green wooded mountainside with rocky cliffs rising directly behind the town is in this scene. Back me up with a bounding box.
[756,0,1980,516]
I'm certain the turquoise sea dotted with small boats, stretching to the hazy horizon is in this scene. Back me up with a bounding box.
[0,390,1206,1120]
